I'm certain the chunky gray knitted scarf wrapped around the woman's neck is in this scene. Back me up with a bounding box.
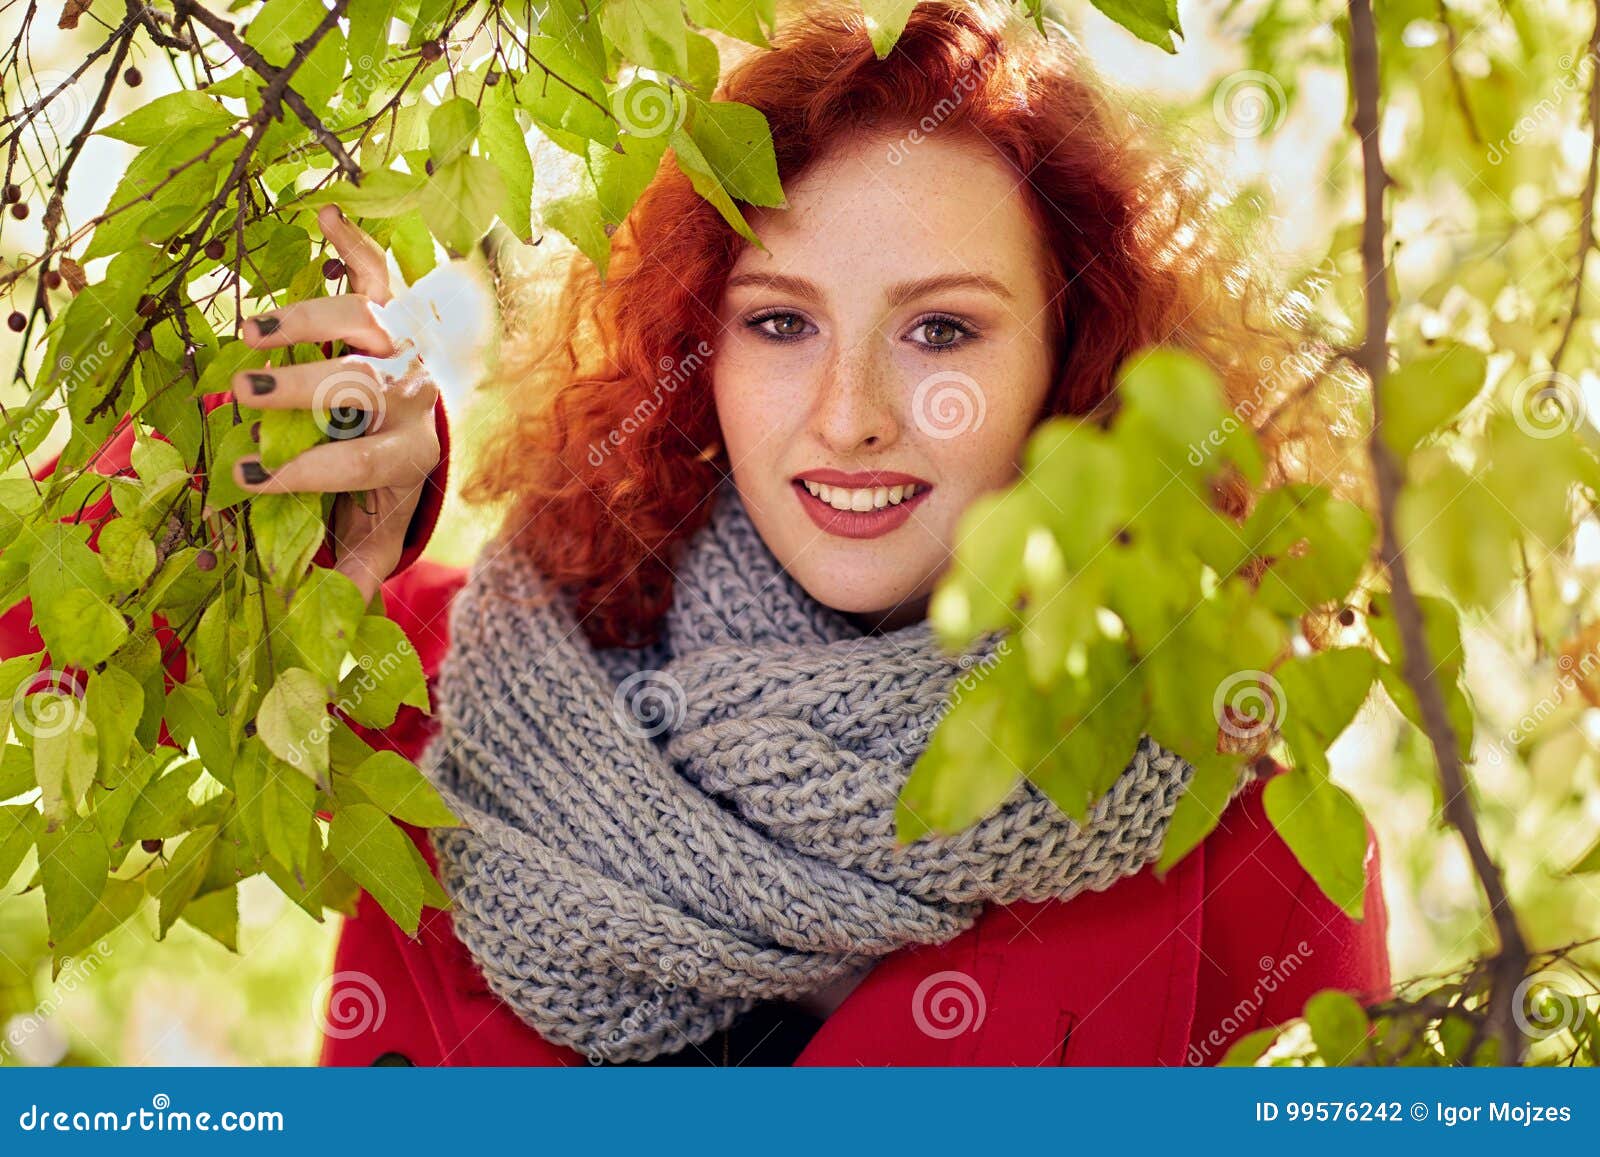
[421,483,1194,1063]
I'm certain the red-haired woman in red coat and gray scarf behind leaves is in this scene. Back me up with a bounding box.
[9,3,1389,1064]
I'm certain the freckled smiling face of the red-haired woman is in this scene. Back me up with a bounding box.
[712,136,1053,629]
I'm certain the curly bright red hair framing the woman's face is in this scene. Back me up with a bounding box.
[464,0,1350,647]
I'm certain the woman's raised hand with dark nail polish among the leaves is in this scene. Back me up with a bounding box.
[232,205,440,602]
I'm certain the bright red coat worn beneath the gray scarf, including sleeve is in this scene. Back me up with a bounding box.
[0,398,1390,1066]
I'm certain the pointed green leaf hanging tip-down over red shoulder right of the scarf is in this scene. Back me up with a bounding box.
[1262,768,1366,920]
